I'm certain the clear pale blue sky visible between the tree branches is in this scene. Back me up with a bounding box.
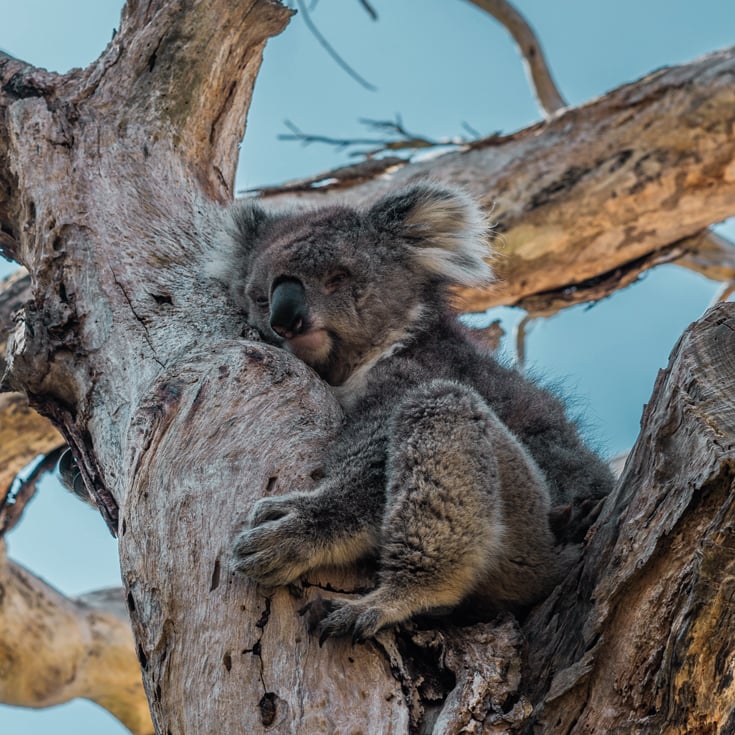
[0,0,735,735]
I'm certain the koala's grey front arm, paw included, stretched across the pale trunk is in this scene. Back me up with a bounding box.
[233,422,385,586]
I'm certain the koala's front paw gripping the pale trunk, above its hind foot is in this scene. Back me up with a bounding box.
[232,494,317,587]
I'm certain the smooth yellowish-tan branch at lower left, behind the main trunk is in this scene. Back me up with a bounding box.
[0,540,153,735]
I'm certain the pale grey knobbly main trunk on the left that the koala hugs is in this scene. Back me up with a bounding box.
[0,0,407,733]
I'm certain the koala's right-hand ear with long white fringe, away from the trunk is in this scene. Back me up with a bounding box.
[368,183,492,286]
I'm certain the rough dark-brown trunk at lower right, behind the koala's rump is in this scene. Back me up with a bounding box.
[524,303,735,735]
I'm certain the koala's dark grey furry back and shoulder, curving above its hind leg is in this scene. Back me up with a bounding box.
[348,315,613,505]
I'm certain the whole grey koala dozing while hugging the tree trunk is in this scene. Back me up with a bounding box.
[222,183,612,642]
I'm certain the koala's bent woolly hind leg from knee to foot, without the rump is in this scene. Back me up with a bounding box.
[319,380,536,640]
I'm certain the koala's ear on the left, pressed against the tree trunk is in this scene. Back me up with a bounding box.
[207,199,274,283]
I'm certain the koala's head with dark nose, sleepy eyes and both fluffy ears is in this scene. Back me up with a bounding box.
[221,184,491,385]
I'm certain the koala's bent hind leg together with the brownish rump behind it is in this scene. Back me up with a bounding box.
[314,380,568,640]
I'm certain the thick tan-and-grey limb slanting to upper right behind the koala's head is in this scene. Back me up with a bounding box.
[258,49,735,311]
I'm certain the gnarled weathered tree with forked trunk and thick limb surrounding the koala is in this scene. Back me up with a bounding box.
[0,0,735,735]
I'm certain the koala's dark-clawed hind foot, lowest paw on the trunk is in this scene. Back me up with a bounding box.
[301,597,386,646]
